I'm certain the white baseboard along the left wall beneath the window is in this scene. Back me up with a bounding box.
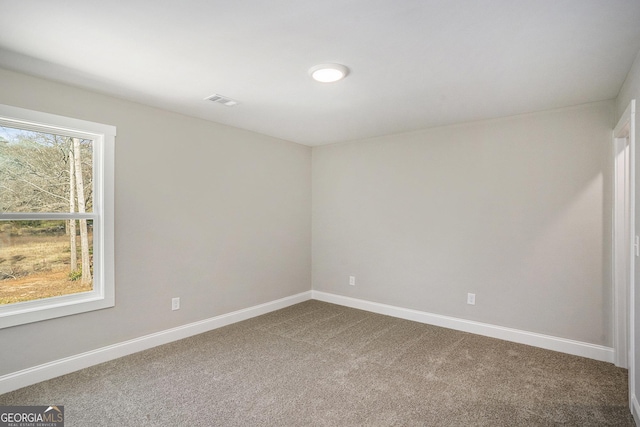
[0,291,311,394]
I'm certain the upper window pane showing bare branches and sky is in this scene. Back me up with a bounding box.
[0,126,93,213]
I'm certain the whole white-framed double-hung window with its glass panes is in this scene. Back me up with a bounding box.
[0,105,116,328]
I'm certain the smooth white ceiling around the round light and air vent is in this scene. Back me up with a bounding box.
[0,0,640,145]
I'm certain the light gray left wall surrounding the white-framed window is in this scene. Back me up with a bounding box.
[0,70,311,375]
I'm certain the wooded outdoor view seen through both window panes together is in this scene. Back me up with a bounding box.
[0,127,93,304]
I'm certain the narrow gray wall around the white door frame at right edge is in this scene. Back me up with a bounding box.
[616,46,640,414]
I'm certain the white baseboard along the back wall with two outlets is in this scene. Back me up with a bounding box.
[311,291,614,363]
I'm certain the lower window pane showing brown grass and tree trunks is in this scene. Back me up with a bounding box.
[0,220,93,304]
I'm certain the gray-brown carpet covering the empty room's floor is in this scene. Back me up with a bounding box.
[0,301,634,427]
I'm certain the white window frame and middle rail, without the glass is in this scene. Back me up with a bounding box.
[0,104,116,329]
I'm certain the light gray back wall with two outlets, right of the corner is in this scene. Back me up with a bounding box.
[312,101,614,346]
